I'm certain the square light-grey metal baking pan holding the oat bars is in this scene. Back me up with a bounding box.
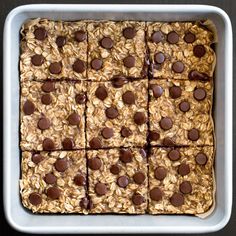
[3,5,233,233]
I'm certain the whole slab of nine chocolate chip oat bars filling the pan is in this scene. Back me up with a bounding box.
[20,19,216,215]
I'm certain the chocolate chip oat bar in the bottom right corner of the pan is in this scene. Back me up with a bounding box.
[148,146,214,214]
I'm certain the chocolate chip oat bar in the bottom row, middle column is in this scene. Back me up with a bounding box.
[87,148,148,214]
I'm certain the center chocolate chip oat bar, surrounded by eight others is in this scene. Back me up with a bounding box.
[86,80,148,149]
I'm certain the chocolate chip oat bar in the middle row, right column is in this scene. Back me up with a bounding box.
[149,79,213,146]
